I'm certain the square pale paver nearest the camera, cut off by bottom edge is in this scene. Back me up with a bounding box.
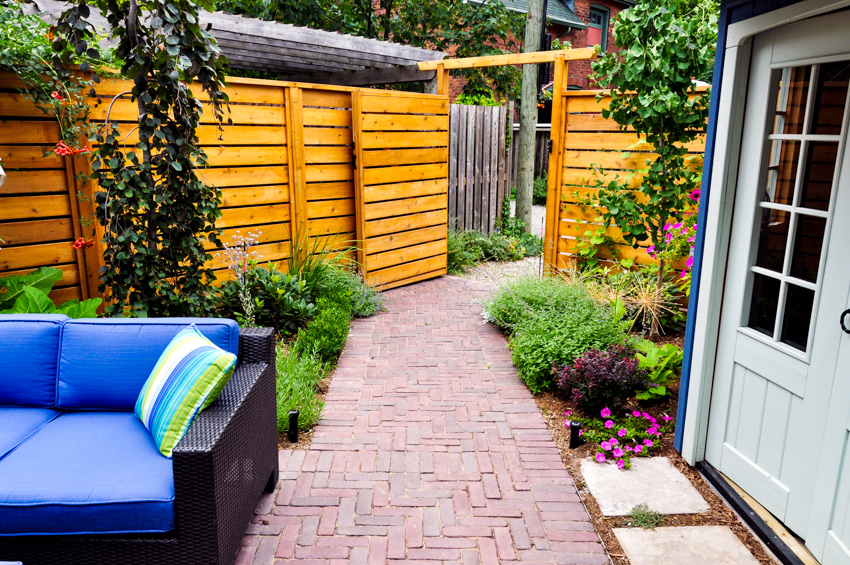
[614,526,758,565]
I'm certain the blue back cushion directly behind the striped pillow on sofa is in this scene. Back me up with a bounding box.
[57,318,239,411]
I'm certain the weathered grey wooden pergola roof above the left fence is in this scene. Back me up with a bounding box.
[30,0,446,76]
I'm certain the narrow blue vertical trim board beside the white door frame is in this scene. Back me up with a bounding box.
[673,0,727,451]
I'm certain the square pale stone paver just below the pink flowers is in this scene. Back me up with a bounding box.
[581,457,710,516]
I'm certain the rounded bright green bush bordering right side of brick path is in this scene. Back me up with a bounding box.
[484,277,626,394]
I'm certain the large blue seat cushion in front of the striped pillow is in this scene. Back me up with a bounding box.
[0,412,174,536]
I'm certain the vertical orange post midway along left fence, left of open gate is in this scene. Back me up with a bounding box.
[284,86,310,251]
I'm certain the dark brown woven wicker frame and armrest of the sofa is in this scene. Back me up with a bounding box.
[0,328,278,565]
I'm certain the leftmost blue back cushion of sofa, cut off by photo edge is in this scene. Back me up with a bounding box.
[0,314,68,407]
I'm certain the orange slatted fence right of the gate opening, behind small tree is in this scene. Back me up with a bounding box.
[544,89,705,268]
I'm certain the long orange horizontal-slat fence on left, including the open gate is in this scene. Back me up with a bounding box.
[0,74,448,301]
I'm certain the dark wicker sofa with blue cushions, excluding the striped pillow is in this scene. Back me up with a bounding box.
[0,315,278,565]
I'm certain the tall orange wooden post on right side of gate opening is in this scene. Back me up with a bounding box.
[543,56,568,269]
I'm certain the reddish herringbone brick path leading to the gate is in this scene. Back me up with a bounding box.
[237,277,608,565]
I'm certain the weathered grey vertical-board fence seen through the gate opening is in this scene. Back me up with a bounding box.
[449,102,515,234]
